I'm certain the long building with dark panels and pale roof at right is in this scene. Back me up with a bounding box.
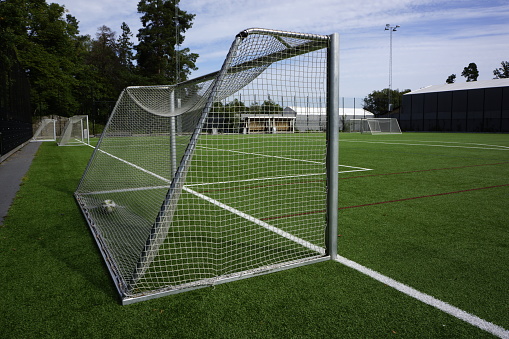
[400,79,509,132]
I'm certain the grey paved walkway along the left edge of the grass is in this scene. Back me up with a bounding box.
[0,142,41,225]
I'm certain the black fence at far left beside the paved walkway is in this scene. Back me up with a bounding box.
[0,55,33,156]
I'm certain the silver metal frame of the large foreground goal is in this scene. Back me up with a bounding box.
[75,29,339,305]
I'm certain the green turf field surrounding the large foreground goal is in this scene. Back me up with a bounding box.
[0,133,509,338]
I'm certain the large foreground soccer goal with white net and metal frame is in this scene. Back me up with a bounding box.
[75,29,339,304]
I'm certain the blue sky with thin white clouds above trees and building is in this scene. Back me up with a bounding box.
[54,0,509,98]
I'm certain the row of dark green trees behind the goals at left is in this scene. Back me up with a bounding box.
[0,0,198,125]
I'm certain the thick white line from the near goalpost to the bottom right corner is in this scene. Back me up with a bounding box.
[336,255,509,339]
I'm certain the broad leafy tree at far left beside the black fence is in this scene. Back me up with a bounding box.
[4,0,84,116]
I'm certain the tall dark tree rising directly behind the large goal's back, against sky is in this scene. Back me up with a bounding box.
[136,0,198,83]
